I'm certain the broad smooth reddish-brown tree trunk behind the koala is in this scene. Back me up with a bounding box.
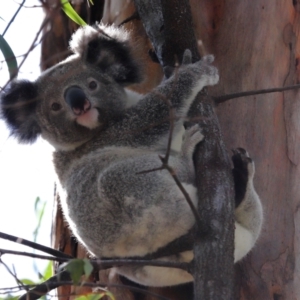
[43,0,300,300]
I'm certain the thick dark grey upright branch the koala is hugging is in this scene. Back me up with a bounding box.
[134,0,234,300]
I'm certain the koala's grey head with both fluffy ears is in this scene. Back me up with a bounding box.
[0,25,140,150]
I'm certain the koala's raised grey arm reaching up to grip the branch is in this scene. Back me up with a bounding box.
[112,50,219,146]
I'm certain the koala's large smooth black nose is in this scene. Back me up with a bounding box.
[64,86,91,115]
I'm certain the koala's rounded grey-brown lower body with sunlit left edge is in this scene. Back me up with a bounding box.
[63,148,194,257]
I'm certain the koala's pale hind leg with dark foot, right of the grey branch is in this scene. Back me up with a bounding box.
[232,148,263,261]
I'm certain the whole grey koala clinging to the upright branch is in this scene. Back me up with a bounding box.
[0,24,263,286]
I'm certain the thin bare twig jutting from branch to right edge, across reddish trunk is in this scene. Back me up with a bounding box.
[212,84,300,105]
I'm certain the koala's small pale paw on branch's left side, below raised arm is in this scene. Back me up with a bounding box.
[181,125,204,157]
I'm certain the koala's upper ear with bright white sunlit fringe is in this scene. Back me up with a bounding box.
[70,24,142,85]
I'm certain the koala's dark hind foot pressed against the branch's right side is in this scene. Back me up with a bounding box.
[232,148,255,207]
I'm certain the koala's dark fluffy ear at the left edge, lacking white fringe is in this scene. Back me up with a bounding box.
[0,80,41,143]
